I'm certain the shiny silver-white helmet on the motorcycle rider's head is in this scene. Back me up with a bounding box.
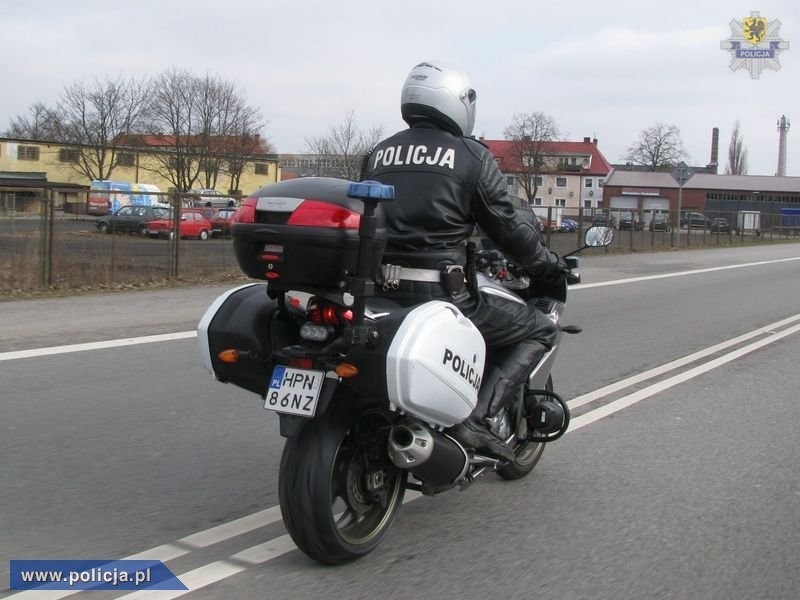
[400,62,476,135]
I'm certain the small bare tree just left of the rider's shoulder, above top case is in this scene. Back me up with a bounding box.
[306,110,383,181]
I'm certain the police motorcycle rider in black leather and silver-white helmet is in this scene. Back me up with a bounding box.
[362,62,568,457]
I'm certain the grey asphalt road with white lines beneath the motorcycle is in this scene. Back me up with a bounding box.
[0,245,800,599]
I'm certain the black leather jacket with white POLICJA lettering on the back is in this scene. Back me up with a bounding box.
[363,123,559,277]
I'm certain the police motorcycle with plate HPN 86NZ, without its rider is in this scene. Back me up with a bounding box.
[197,178,613,564]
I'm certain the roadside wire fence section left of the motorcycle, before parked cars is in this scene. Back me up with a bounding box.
[0,191,240,292]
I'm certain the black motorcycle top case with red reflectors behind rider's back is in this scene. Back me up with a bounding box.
[231,177,386,292]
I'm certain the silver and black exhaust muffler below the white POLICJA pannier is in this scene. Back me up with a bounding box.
[388,419,469,491]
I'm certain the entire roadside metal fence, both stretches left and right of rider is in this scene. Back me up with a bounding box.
[0,191,800,292]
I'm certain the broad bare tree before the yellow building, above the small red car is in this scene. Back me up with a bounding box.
[143,69,263,191]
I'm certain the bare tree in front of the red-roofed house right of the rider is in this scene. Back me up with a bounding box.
[503,112,561,204]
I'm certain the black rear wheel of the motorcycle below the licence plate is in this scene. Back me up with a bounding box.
[278,399,407,565]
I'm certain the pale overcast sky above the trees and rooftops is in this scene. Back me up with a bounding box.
[0,0,800,176]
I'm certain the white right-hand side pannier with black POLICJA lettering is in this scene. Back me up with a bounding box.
[386,300,486,427]
